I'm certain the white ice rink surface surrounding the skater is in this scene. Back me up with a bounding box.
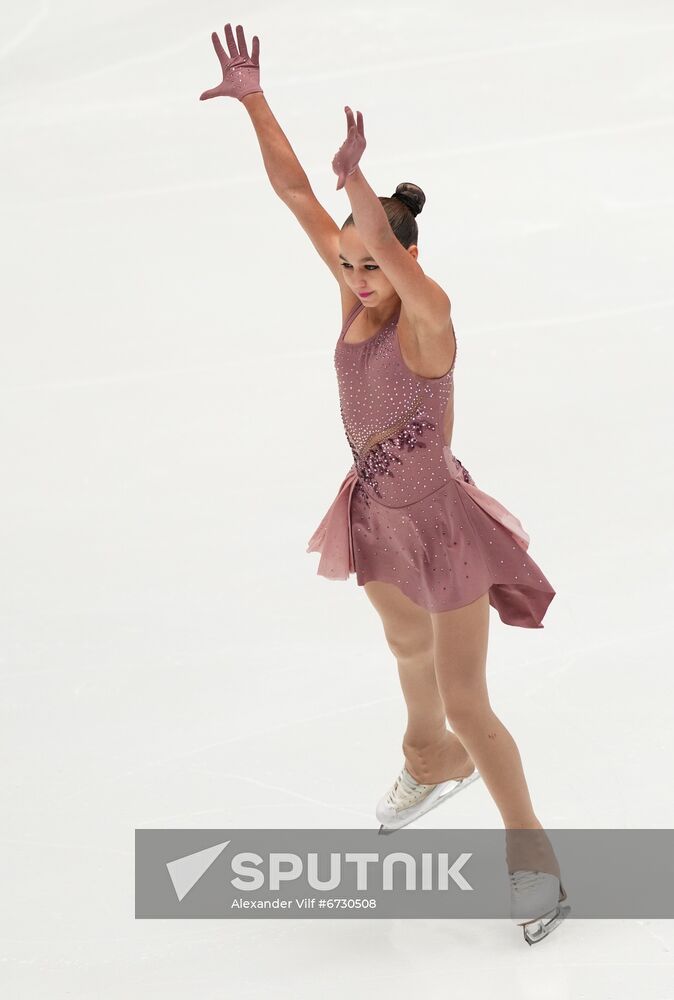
[0,0,674,1000]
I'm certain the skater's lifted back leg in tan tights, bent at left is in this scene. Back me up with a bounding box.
[364,581,475,784]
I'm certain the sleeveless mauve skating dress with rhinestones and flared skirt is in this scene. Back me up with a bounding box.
[307,302,555,628]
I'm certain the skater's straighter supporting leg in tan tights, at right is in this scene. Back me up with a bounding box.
[430,593,559,876]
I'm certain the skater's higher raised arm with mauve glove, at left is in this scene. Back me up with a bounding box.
[200,24,357,290]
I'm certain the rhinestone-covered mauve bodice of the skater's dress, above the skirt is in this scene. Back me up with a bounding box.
[334,303,454,507]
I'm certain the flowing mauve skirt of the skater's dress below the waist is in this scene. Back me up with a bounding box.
[307,446,555,628]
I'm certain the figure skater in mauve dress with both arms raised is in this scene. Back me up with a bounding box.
[200,24,569,943]
